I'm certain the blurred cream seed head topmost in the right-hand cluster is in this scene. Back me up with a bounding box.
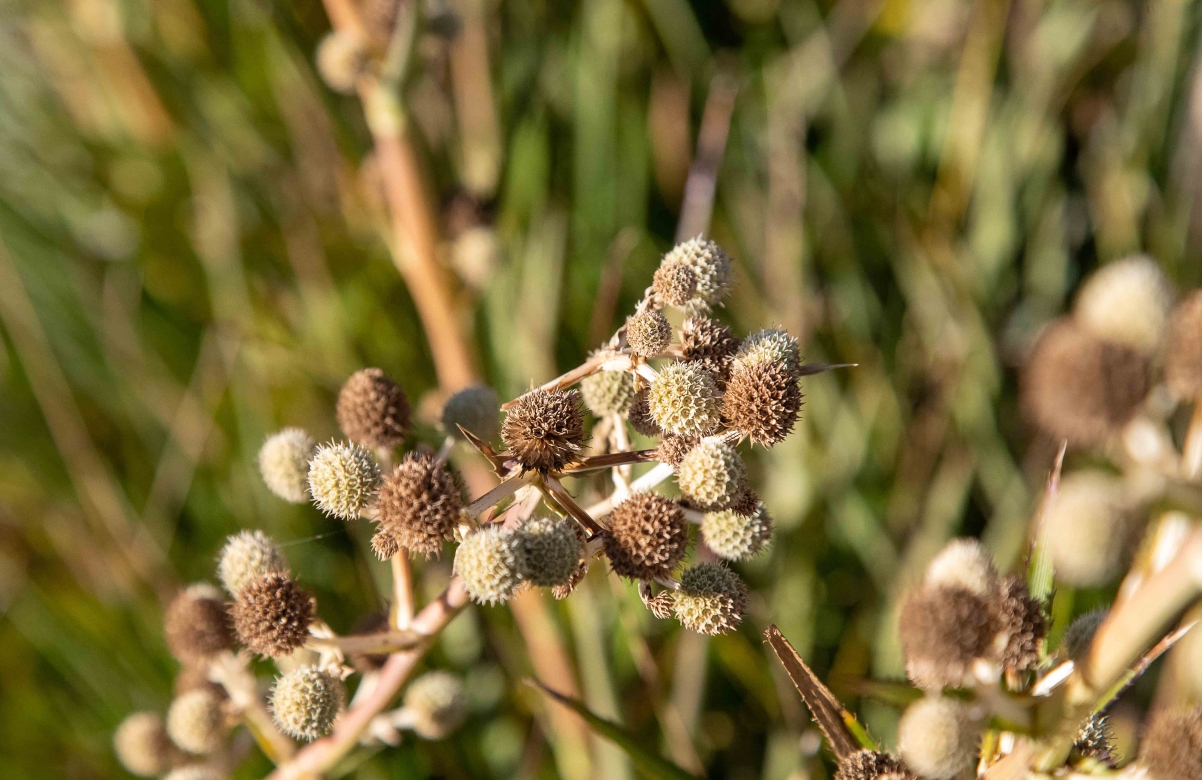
[1073,255,1173,356]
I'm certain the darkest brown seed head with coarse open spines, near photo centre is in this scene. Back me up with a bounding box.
[501,389,584,474]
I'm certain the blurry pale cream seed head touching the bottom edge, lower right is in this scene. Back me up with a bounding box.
[898,696,981,780]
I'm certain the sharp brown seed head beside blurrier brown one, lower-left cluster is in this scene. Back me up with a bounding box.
[231,574,314,657]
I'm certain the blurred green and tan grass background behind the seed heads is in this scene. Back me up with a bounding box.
[0,0,1202,780]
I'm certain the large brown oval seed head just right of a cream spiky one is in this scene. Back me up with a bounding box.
[376,452,463,558]
